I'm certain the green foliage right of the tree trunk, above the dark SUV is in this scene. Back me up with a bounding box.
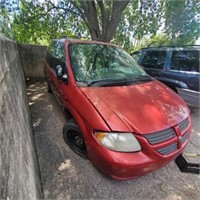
[114,0,200,52]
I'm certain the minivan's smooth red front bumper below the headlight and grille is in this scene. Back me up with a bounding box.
[88,134,191,180]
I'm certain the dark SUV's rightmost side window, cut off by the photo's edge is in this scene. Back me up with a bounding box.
[171,50,199,72]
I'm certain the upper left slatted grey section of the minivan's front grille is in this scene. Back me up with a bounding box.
[144,128,176,144]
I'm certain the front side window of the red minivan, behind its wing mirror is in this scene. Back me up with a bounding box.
[52,42,66,74]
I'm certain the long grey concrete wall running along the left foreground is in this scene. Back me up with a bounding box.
[0,35,41,200]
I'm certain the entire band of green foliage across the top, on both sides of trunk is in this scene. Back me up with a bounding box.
[0,0,200,48]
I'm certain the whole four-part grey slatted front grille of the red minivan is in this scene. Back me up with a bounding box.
[144,118,190,155]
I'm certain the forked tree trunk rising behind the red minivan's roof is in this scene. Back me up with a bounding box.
[70,0,130,42]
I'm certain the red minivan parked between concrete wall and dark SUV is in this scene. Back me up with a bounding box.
[44,39,191,179]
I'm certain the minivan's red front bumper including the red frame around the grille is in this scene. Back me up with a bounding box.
[88,118,191,180]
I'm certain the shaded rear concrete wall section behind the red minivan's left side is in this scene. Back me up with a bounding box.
[18,44,47,80]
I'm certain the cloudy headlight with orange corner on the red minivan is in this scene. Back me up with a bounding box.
[94,132,141,152]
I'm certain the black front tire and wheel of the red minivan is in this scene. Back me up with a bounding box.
[63,119,87,158]
